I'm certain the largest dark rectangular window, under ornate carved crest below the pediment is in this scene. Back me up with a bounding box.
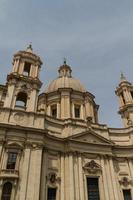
[87,178,100,200]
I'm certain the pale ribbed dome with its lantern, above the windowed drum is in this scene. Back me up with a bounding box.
[45,61,86,93]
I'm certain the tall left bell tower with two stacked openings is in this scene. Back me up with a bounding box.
[4,45,42,112]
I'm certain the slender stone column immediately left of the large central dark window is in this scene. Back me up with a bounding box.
[78,155,85,200]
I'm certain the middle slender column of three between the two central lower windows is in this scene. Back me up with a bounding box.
[69,153,75,200]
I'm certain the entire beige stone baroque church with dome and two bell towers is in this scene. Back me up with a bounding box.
[0,45,133,200]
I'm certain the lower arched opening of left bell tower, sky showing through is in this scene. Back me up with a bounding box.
[15,92,27,108]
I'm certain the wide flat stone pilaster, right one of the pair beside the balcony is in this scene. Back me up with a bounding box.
[26,146,42,200]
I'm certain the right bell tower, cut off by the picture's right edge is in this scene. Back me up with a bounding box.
[115,73,133,127]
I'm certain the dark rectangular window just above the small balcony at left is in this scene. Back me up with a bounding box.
[6,152,17,169]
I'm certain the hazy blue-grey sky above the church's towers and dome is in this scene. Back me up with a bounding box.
[0,0,133,127]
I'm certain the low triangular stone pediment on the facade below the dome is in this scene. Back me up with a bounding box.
[70,130,113,145]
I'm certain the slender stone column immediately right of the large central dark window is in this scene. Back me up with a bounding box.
[101,157,110,200]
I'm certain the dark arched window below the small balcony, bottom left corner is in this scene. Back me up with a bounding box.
[1,182,12,200]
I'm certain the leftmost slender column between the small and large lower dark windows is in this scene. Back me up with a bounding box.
[60,153,65,200]
